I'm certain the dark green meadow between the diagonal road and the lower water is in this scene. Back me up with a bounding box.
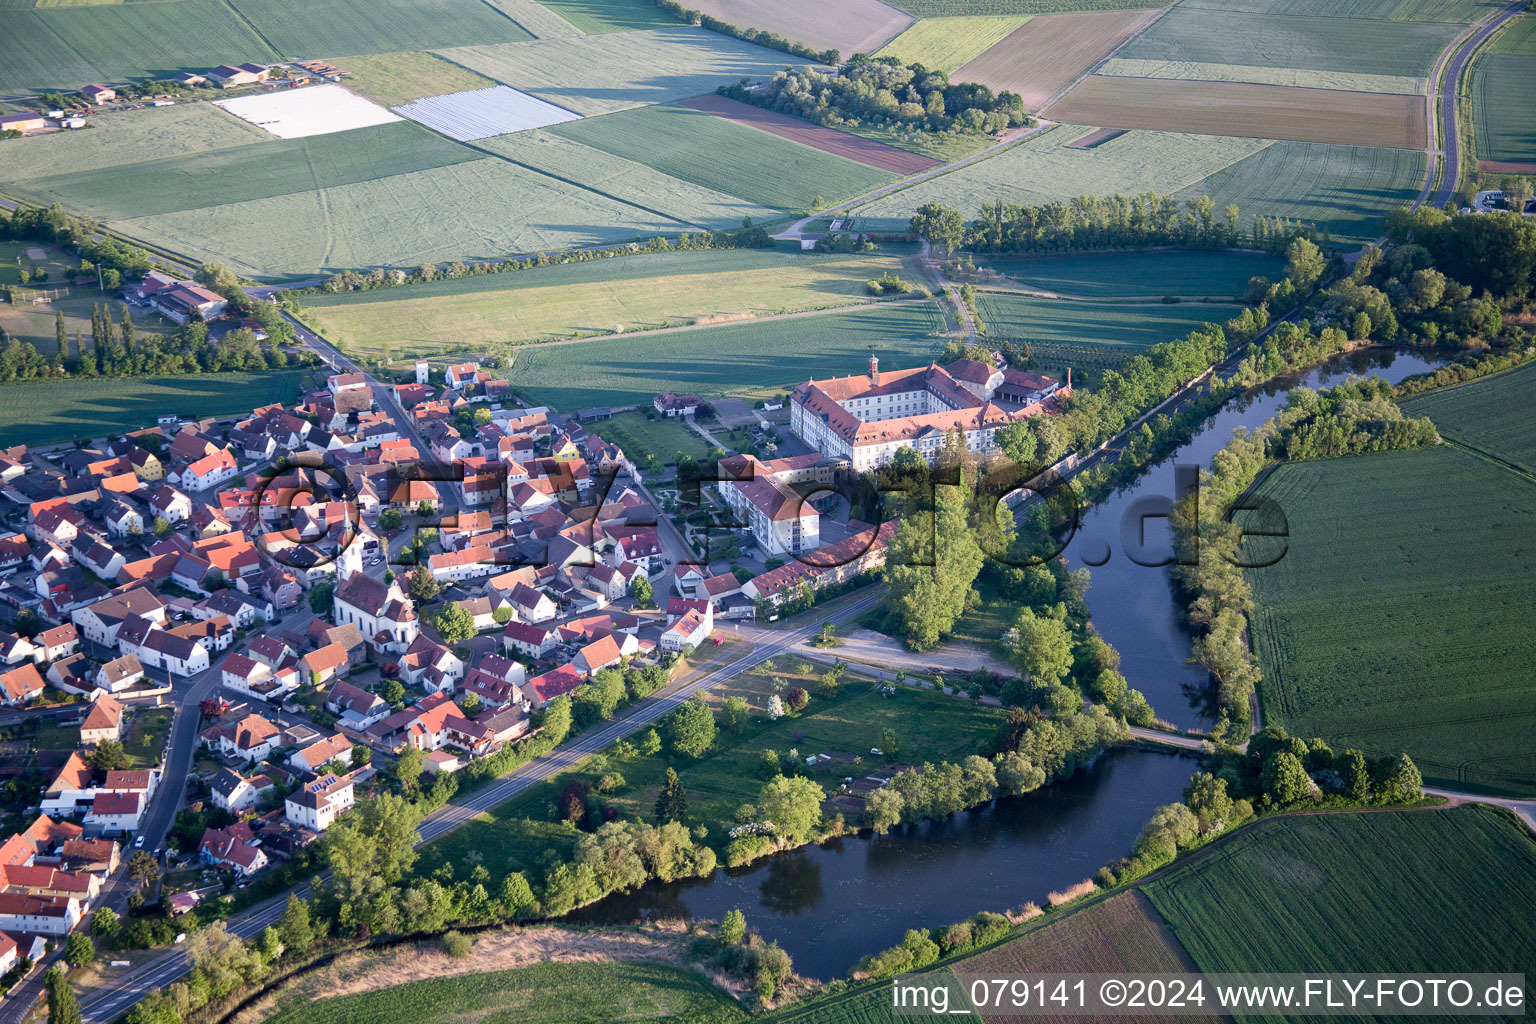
[416,657,1003,878]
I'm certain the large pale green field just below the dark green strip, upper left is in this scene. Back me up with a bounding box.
[115,158,677,276]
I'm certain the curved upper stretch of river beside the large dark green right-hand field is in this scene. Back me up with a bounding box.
[1064,348,1444,729]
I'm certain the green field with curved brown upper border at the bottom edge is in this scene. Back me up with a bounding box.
[267,963,746,1024]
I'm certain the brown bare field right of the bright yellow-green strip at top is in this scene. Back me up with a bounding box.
[954,11,1158,111]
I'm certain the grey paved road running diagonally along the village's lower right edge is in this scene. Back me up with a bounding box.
[81,590,882,1024]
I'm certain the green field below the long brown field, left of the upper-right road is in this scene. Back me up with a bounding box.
[1178,143,1425,244]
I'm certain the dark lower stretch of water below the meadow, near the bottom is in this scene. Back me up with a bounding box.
[570,749,1198,978]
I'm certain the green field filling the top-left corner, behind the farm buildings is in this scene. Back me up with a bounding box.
[0,0,278,95]
